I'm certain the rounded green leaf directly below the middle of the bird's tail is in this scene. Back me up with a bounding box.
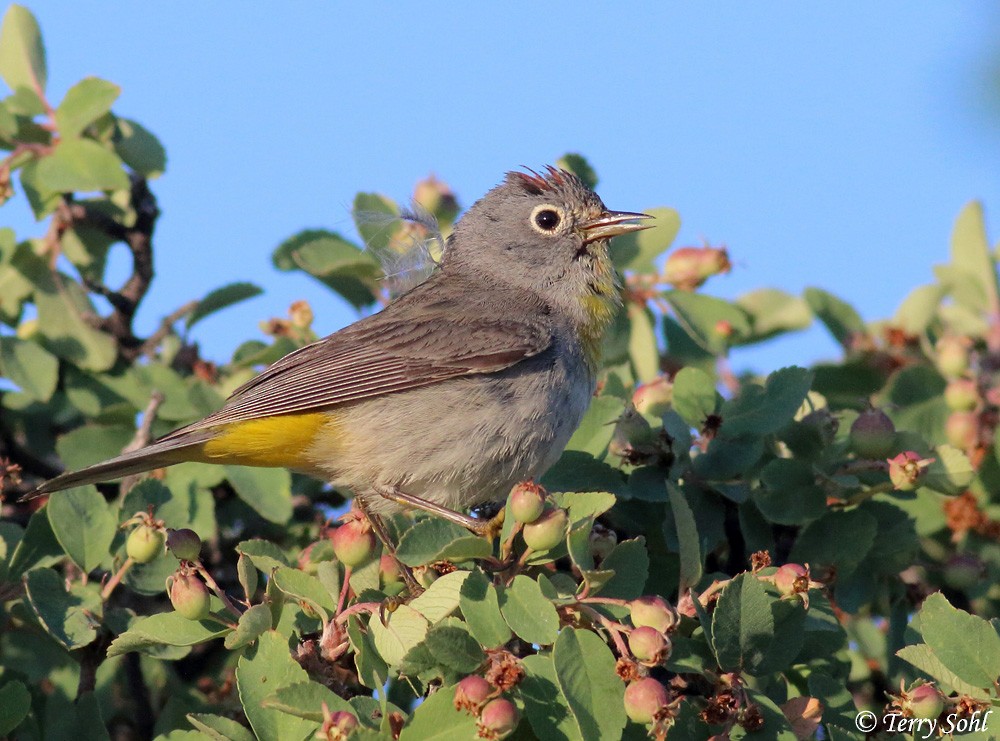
[46,485,118,573]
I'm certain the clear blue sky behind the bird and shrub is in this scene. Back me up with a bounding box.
[0,0,1000,371]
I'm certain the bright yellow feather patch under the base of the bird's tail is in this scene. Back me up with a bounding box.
[199,412,337,468]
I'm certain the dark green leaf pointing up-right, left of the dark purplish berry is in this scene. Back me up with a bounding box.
[720,366,813,437]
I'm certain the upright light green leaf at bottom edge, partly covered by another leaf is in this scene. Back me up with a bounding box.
[236,631,316,739]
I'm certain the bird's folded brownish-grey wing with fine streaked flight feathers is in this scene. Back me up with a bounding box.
[163,307,551,440]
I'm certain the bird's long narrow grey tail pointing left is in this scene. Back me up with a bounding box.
[22,430,214,500]
